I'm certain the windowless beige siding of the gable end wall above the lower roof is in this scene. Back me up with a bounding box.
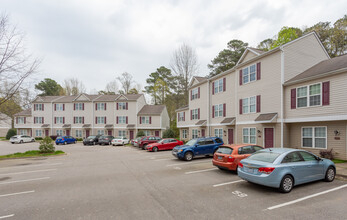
[284,34,329,81]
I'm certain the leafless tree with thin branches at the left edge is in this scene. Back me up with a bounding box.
[0,15,40,105]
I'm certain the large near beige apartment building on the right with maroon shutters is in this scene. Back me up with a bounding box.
[176,32,347,159]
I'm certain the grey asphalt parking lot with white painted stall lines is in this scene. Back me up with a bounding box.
[0,142,347,219]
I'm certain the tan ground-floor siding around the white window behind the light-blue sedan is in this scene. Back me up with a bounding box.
[290,121,347,160]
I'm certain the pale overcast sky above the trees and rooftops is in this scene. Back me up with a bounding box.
[0,0,347,95]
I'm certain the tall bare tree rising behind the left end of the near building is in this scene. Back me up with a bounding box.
[170,44,198,104]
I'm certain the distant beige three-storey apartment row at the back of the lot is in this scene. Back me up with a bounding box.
[15,93,170,139]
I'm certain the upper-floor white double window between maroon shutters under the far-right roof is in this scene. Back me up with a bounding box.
[296,83,322,108]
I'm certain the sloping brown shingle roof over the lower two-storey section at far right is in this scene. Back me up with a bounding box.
[284,54,347,85]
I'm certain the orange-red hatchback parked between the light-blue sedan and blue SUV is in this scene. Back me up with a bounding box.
[212,144,263,171]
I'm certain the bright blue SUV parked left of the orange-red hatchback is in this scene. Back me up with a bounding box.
[172,137,224,161]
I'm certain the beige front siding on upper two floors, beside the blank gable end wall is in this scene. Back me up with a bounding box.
[235,52,281,123]
